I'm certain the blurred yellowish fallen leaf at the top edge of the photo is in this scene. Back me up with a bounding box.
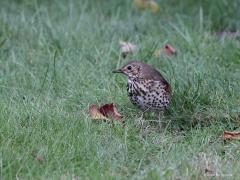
[133,0,159,13]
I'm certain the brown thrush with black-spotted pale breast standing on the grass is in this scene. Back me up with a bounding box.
[113,60,171,115]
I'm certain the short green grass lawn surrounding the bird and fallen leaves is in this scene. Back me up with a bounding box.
[0,0,240,179]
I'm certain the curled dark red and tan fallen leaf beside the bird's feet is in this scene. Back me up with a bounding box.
[89,103,123,122]
